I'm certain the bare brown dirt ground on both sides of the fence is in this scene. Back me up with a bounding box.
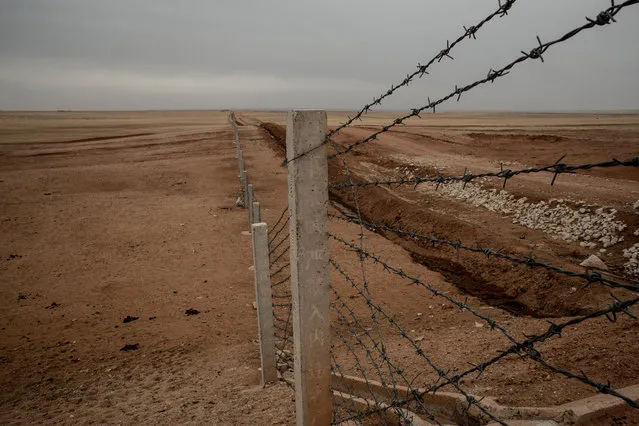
[0,111,639,424]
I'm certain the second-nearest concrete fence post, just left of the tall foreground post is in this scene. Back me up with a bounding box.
[251,223,277,386]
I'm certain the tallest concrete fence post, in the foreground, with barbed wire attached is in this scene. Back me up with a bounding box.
[286,110,332,426]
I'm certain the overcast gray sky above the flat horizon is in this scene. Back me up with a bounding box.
[0,0,639,111]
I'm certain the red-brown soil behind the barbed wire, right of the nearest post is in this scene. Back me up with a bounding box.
[262,114,639,422]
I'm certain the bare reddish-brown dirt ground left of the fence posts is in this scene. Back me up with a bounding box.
[0,112,293,424]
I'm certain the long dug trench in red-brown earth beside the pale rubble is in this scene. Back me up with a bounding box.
[260,123,610,318]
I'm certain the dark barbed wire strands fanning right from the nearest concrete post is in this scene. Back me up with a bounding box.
[324,2,639,424]
